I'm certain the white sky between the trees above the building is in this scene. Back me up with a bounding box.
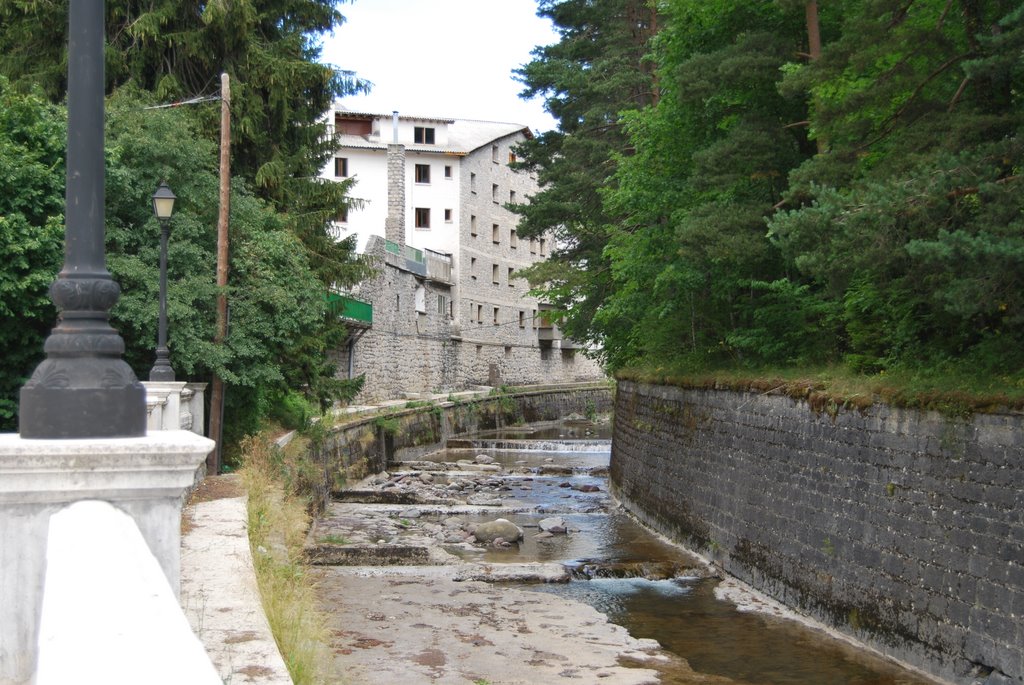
[321,0,558,131]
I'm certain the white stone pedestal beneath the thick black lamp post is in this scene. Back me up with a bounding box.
[0,430,214,685]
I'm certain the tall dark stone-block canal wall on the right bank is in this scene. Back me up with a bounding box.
[610,381,1024,685]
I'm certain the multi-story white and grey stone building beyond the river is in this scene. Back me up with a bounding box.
[324,108,603,399]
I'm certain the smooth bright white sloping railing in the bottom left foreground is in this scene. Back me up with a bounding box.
[35,501,222,685]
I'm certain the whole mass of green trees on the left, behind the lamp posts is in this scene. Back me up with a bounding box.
[0,0,370,448]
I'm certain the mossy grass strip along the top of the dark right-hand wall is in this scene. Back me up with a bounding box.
[616,366,1024,417]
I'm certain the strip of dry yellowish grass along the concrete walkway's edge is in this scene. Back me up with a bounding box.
[240,434,330,685]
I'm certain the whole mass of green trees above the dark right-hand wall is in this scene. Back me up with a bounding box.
[521,0,1024,386]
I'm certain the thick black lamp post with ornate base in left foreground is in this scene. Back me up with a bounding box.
[18,0,146,439]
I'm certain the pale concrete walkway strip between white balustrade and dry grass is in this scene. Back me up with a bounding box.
[181,475,292,685]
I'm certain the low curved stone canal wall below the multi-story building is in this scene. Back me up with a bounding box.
[312,382,614,506]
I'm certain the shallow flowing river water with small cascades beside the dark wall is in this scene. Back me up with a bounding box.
[417,417,932,685]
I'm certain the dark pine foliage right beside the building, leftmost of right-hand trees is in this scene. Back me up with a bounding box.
[515,0,656,350]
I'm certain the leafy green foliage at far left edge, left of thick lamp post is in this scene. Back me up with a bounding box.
[0,77,66,432]
